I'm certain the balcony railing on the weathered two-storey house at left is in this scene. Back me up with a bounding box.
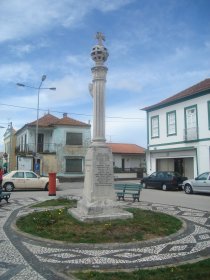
[15,143,56,154]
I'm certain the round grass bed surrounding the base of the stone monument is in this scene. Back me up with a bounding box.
[17,200,182,243]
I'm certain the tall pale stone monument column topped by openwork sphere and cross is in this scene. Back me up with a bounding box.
[70,32,133,222]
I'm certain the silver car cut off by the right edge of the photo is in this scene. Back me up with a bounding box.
[182,172,210,194]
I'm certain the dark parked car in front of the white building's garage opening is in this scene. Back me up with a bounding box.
[141,171,188,191]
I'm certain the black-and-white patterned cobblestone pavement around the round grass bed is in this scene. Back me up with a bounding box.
[0,198,210,280]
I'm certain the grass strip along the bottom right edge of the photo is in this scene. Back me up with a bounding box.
[73,259,210,280]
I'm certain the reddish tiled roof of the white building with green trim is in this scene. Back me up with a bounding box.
[142,79,210,111]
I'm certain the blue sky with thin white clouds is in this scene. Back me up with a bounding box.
[0,0,210,150]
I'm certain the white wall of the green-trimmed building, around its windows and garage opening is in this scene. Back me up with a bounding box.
[147,94,210,178]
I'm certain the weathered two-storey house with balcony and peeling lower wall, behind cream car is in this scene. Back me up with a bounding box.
[16,114,91,177]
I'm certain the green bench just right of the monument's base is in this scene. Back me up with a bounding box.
[114,184,143,202]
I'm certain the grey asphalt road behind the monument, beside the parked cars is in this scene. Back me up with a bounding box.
[8,182,210,211]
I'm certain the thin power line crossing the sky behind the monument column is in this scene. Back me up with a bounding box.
[0,103,145,120]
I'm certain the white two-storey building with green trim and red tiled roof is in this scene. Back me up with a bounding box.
[142,79,210,178]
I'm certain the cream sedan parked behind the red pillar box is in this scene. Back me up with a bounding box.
[2,170,59,192]
